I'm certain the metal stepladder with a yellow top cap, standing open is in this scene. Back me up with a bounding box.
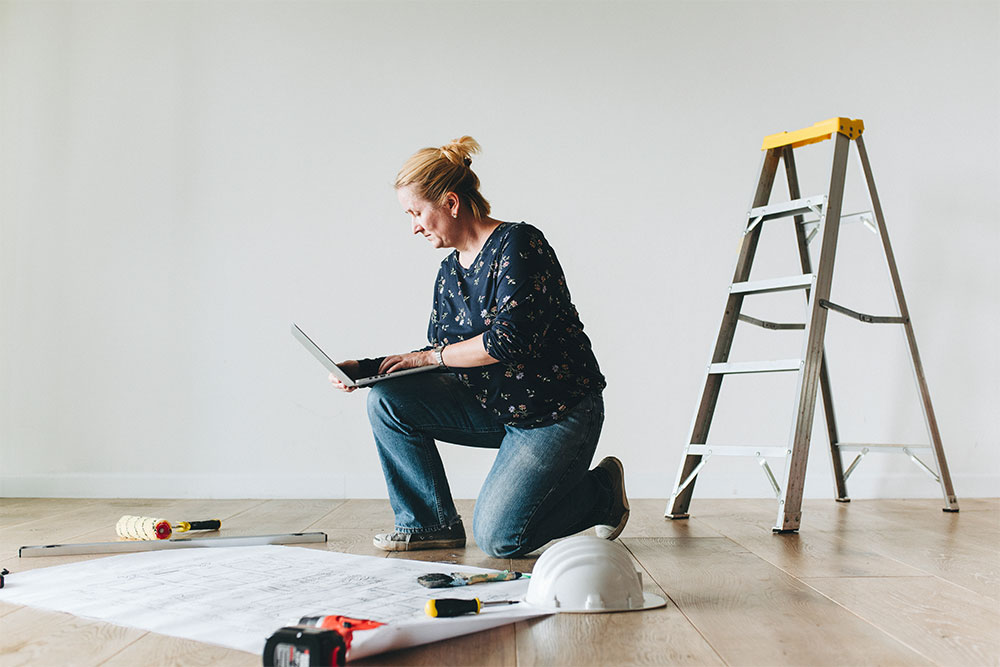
[666,118,958,533]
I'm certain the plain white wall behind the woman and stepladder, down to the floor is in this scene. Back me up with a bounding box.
[0,1,1000,498]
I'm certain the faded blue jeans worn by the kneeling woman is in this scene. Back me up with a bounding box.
[368,372,611,558]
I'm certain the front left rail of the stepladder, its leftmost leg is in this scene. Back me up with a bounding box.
[665,148,780,519]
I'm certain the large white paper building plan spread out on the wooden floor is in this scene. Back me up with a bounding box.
[0,545,549,659]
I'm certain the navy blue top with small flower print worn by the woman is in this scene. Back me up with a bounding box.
[427,222,607,428]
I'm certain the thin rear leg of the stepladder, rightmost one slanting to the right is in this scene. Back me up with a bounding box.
[857,136,958,512]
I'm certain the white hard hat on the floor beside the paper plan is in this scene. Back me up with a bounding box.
[524,535,666,613]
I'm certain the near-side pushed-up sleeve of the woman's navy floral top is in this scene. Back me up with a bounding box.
[483,226,564,363]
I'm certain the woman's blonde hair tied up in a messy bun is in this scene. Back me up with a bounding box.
[396,137,490,220]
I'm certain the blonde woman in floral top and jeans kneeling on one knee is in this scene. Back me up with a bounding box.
[330,137,629,558]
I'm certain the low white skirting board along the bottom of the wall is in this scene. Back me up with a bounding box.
[0,464,1000,505]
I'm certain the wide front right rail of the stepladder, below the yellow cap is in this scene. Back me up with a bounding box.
[774,134,850,532]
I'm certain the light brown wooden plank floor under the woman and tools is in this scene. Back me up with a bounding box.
[0,499,1000,667]
